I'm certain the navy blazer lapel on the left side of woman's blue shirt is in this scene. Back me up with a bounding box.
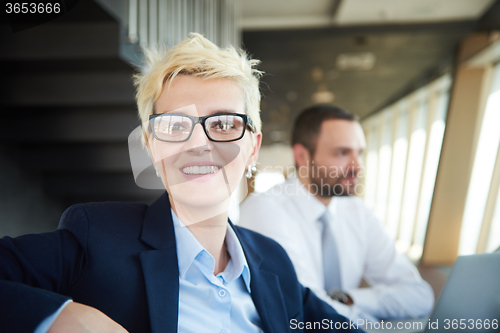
[139,193,179,333]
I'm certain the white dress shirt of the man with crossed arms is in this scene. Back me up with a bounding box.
[239,178,434,321]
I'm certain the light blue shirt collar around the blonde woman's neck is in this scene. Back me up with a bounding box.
[171,209,250,292]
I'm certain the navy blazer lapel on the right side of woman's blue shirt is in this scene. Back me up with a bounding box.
[231,224,289,333]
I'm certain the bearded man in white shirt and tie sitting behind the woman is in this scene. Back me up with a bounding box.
[239,105,434,321]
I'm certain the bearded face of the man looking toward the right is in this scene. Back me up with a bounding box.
[309,119,366,197]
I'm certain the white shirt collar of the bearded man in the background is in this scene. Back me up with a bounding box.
[285,177,338,223]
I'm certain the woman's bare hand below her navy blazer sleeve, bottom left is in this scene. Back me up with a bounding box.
[48,302,127,333]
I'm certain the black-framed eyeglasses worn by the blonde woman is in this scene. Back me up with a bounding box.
[149,113,255,142]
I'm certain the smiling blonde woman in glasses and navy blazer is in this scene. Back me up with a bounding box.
[0,34,364,333]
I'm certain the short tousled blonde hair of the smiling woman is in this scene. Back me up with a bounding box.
[133,33,262,139]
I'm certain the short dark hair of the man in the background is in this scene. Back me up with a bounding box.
[292,104,358,157]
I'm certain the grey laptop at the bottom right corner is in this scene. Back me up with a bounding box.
[364,252,500,333]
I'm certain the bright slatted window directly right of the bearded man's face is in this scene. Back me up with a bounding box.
[362,75,451,260]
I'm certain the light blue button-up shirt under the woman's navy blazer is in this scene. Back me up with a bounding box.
[172,211,262,333]
